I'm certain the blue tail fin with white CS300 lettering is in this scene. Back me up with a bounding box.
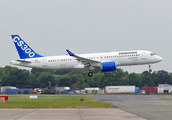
[11,35,43,59]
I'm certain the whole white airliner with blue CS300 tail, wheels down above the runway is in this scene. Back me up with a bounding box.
[10,35,162,77]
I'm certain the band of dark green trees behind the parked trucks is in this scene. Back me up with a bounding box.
[0,66,172,89]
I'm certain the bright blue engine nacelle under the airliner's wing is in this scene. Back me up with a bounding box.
[102,61,116,72]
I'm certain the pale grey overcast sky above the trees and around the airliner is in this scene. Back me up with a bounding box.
[0,0,172,73]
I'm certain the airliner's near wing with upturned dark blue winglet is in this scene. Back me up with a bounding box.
[66,49,101,67]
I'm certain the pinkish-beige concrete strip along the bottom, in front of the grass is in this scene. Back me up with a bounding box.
[0,108,145,120]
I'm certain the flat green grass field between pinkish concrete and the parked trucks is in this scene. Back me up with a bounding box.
[0,95,113,108]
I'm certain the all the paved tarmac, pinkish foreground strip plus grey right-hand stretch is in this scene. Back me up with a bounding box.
[0,95,172,120]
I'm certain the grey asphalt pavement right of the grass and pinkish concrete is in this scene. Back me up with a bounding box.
[93,95,172,120]
